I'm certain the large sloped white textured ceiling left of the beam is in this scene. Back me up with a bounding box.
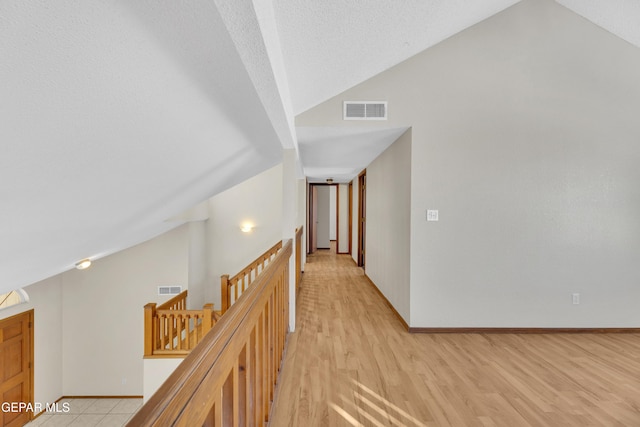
[0,0,286,290]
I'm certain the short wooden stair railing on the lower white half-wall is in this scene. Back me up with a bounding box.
[144,291,219,357]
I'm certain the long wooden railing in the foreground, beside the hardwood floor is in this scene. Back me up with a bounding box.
[127,240,292,427]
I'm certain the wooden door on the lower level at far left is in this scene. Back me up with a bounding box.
[0,310,33,427]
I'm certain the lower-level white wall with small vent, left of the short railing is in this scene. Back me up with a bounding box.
[62,225,188,397]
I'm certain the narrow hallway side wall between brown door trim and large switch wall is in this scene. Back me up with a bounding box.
[365,130,411,323]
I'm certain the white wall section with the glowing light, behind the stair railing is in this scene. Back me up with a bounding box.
[205,164,283,309]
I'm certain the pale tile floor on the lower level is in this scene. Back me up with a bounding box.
[26,398,142,427]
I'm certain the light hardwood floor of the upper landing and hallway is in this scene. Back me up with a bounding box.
[270,250,640,427]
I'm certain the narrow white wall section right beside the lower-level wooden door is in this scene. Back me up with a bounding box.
[0,275,62,412]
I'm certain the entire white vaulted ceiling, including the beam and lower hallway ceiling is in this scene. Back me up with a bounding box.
[0,0,640,291]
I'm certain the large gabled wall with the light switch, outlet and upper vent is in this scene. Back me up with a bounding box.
[296,0,640,328]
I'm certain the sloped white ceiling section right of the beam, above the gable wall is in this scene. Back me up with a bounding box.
[275,0,518,114]
